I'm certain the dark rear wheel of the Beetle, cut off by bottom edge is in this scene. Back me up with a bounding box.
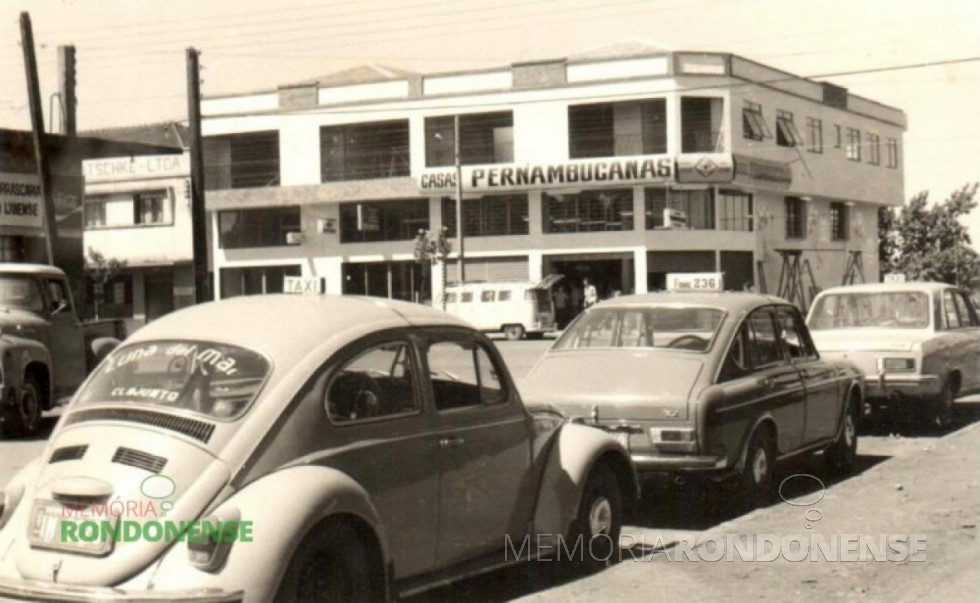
[276,523,382,601]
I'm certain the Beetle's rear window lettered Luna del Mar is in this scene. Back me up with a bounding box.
[78,341,270,419]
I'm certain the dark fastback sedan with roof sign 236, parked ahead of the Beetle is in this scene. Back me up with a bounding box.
[522,292,862,502]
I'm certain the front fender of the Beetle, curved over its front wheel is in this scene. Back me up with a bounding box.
[534,423,640,538]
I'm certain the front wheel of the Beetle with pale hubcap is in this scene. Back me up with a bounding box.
[565,463,623,567]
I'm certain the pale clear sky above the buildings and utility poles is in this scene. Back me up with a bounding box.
[0,0,980,238]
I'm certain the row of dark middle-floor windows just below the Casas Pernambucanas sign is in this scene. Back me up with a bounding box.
[218,187,752,249]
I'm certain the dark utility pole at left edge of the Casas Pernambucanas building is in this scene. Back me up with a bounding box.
[187,48,211,303]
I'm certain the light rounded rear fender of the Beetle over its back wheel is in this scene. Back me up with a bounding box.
[151,465,388,601]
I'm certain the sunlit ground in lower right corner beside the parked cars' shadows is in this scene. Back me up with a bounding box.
[525,423,980,603]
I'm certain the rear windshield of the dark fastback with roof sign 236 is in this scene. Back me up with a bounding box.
[555,305,725,352]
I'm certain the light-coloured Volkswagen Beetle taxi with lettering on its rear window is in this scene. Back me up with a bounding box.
[0,295,638,601]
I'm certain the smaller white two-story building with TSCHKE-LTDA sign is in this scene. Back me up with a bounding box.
[82,122,194,329]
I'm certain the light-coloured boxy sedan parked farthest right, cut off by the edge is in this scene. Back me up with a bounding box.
[807,282,980,427]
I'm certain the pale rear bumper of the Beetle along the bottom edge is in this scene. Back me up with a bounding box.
[0,578,244,603]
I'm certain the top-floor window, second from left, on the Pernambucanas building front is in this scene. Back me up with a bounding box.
[320,119,410,182]
